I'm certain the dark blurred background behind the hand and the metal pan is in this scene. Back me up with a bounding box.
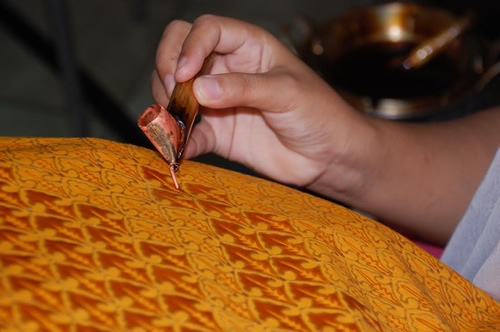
[0,0,500,169]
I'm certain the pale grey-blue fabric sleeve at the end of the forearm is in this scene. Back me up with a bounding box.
[442,149,500,301]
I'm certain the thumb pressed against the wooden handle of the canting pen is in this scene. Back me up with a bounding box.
[193,72,298,111]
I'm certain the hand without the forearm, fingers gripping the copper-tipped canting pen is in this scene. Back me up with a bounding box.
[152,15,372,186]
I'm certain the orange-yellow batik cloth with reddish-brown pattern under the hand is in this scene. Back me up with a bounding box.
[0,138,500,331]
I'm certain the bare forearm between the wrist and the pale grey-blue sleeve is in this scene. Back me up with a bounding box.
[311,109,500,244]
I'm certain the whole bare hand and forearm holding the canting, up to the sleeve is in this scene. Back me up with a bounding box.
[152,16,500,243]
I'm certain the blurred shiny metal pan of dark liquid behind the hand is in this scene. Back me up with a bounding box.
[288,3,500,119]
